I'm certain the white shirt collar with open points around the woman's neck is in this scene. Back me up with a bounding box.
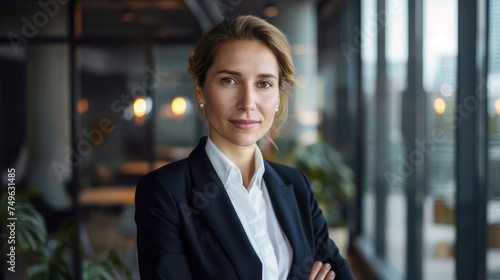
[205,137,265,190]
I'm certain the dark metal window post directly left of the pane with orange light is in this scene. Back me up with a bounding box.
[403,1,426,280]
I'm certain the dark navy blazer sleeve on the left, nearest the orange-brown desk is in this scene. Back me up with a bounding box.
[135,172,192,280]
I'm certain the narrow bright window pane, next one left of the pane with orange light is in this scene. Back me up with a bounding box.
[384,0,408,275]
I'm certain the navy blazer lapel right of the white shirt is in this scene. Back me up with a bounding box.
[264,161,310,268]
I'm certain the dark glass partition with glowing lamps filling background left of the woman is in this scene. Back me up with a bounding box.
[0,0,203,279]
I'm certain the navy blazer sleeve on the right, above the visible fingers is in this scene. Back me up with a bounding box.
[301,172,354,280]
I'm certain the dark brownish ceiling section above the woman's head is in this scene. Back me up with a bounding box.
[79,0,304,38]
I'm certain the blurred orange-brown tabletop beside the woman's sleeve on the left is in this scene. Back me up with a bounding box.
[79,186,135,206]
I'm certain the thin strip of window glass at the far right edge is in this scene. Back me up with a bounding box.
[487,1,500,280]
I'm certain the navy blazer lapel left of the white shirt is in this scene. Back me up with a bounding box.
[189,137,262,280]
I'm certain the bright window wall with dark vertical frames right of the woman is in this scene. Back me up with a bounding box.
[348,0,500,279]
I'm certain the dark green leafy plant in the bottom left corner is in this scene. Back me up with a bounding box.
[0,193,132,280]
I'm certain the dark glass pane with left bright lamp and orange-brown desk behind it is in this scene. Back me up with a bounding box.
[76,45,148,278]
